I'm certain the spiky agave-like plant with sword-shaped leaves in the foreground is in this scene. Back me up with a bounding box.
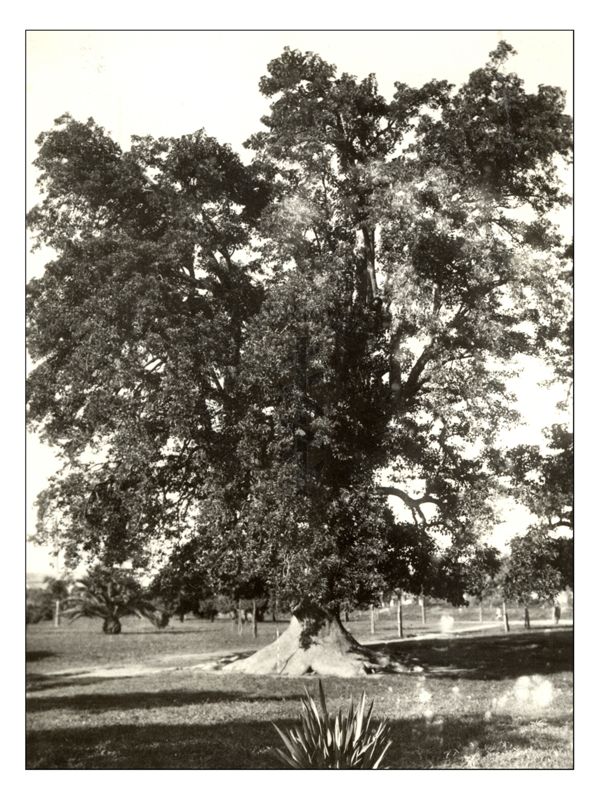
[273,681,392,769]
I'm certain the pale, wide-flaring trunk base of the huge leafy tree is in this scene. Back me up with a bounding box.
[223,603,411,678]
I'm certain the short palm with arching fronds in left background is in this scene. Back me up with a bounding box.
[64,567,169,634]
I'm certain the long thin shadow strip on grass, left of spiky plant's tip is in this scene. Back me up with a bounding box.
[27,687,302,714]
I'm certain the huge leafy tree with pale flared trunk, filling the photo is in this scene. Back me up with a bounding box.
[29,43,571,674]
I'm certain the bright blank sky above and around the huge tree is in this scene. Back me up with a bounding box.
[26,30,573,572]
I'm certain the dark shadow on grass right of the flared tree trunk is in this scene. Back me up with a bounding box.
[373,628,573,680]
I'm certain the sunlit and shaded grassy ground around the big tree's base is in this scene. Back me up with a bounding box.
[27,612,572,769]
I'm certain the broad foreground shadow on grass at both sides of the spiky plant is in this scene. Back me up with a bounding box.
[27,717,569,770]
